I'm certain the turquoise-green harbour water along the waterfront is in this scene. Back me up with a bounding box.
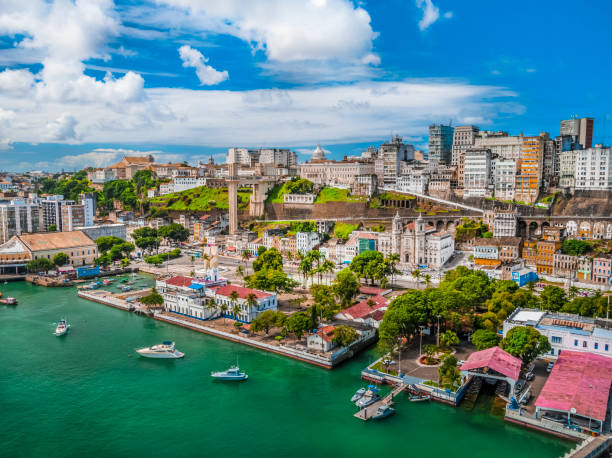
[0,279,573,458]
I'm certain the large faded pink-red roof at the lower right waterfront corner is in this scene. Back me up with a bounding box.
[535,350,612,422]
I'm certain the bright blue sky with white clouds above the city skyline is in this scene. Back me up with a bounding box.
[0,0,612,171]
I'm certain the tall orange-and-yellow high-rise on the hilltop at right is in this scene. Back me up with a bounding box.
[514,133,550,204]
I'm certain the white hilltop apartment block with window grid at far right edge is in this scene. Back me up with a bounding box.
[574,145,612,190]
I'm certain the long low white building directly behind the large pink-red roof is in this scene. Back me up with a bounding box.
[503,307,612,357]
